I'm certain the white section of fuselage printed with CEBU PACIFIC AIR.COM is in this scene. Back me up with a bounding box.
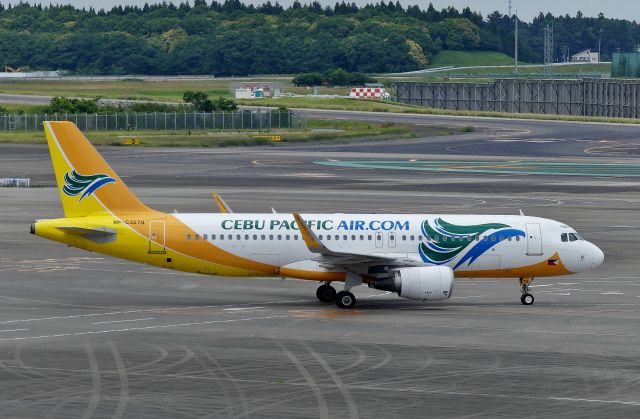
[174,214,604,277]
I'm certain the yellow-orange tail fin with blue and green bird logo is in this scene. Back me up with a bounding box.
[44,121,150,217]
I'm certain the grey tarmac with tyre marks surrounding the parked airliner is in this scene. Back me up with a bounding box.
[0,115,640,418]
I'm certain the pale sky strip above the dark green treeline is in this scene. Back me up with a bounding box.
[5,0,640,21]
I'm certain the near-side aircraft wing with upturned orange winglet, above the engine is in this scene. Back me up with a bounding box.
[293,212,421,266]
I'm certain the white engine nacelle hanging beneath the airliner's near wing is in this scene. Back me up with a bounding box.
[371,266,453,301]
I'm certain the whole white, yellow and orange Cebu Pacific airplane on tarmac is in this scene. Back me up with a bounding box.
[31,121,604,308]
